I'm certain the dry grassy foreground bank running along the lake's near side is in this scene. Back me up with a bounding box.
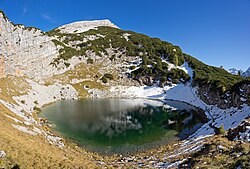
[0,101,250,168]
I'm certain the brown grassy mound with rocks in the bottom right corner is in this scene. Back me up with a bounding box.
[189,135,250,169]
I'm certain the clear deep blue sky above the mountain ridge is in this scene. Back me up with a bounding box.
[0,0,250,70]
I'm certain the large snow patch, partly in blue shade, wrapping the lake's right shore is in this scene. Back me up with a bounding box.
[110,63,250,139]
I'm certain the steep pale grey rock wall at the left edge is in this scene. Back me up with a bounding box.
[0,13,58,79]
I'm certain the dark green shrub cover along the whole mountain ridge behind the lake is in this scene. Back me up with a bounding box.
[46,27,248,93]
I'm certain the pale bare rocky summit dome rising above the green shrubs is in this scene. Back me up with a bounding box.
[57,19,118,33]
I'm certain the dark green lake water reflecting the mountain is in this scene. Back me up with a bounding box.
[42,99,201,153]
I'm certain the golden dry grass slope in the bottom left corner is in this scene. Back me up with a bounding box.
[0,105,106,168]
